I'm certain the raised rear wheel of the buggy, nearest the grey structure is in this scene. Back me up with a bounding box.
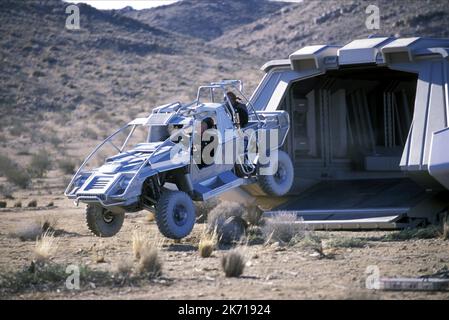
[257,150,294,197]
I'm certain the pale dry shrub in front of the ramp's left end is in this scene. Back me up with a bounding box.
[262,212,306,243]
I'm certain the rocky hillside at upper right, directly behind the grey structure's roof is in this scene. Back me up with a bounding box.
[212,0,449,59]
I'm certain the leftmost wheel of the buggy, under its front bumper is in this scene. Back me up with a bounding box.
[86,204,125,237]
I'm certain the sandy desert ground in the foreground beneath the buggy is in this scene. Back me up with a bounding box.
[0,170,449,299]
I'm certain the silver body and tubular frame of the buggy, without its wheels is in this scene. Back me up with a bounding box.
[65,80,290,212]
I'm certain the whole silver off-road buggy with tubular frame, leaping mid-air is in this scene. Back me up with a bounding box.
[65,80,294,239]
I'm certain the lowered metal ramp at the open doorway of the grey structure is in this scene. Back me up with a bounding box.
[264,178,428,230]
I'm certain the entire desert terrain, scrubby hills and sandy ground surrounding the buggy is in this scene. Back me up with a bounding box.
[0,0,449,299]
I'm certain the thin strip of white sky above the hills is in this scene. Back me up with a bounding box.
[64,0,302,10]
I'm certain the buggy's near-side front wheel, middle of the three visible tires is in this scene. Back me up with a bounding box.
[156,190,196,239]
